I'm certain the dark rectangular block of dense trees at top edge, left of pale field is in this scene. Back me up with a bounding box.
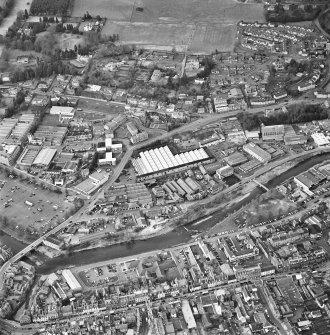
[30,0,71,16]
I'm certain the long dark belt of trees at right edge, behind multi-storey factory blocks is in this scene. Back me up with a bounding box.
[237,105,329,130]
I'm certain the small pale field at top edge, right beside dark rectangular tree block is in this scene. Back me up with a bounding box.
[71,0,134,20]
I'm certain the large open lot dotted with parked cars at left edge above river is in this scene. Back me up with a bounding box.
[0,173,70,235]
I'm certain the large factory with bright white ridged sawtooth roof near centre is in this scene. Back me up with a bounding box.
[132,146,214,180]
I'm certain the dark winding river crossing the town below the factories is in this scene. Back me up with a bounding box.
[0,153,330,274]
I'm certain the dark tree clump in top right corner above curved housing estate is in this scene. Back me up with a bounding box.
[266,4,322,23]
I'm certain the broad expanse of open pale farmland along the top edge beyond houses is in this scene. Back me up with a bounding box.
[72,0,265,53]
